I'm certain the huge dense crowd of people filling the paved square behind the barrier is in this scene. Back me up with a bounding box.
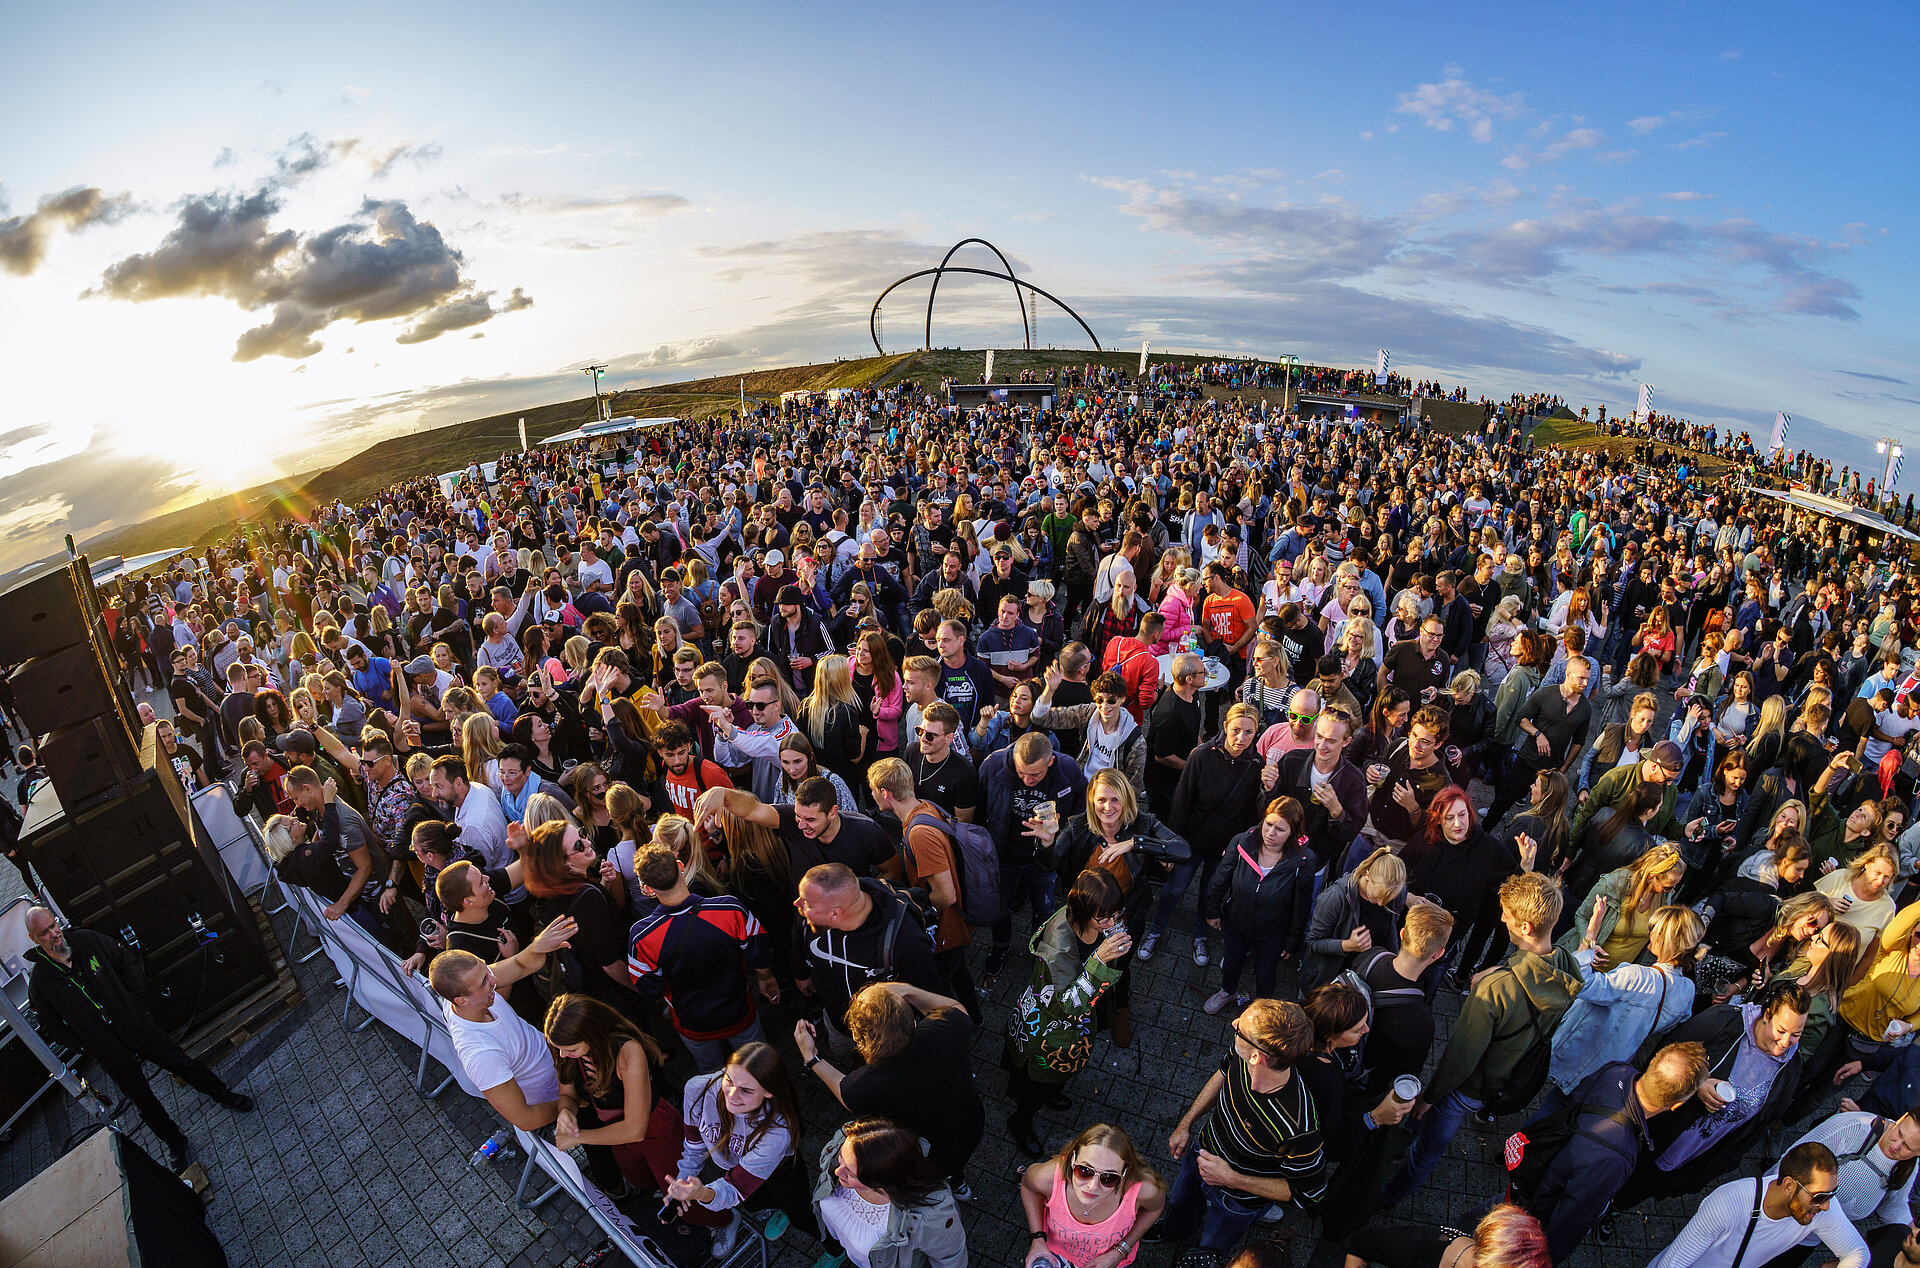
[19,363,1920,1268]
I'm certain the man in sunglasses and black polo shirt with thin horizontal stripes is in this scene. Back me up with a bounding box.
[1165,999,1327,1253]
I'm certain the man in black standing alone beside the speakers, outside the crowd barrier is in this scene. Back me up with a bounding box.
[27,907,253,1172]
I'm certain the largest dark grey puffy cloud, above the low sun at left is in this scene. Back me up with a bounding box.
[88,176,530,361]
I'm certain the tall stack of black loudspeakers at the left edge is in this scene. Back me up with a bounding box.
[0,557,290,1051]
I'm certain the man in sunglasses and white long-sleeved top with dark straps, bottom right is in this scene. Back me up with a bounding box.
[1647,1141,1866,1268]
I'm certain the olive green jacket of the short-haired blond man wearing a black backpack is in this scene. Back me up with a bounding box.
[1421,947,1580,1105]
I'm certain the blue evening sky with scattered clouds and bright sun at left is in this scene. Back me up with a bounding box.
[0,4,1920,569]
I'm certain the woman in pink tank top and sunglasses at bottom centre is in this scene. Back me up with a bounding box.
[1020,1122,1167,1268]
